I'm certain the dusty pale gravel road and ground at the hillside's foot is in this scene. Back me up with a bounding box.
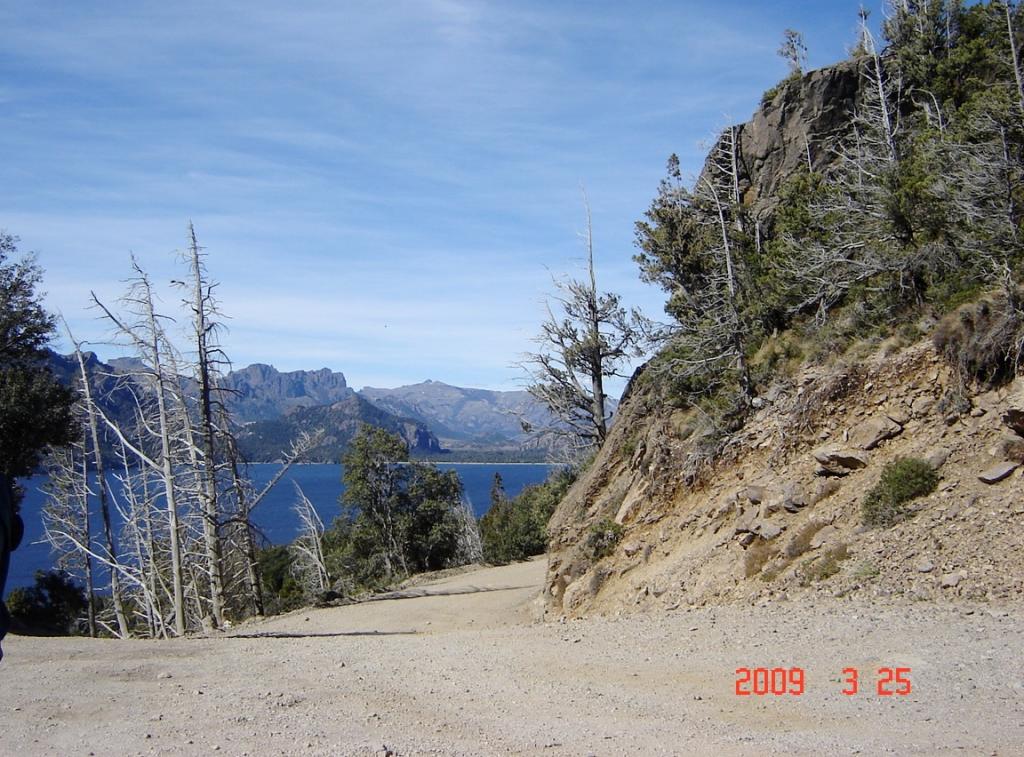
[0,561,1024,757]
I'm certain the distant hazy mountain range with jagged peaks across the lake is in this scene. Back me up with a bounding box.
[50,352,552,462]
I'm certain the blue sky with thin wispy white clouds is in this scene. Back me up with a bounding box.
[0,0,881,389]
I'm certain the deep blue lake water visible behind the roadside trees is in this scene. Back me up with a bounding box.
[7,463,551,591]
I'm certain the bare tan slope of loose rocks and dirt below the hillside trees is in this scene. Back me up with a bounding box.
[545,340,1024,615]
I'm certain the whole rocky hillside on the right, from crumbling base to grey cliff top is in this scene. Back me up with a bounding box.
[544,31,1024,616]
